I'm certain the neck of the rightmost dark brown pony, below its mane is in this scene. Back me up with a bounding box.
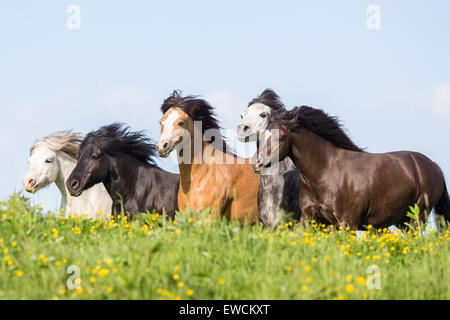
[288,128,344,181]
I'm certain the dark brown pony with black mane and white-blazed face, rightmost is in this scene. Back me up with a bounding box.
[252,106,450,229]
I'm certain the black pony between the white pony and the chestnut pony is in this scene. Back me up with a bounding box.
[66,123,180,218]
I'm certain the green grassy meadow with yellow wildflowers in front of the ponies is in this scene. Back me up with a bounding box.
[0,195,450,299]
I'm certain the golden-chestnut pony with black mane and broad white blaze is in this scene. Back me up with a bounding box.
[156,91,259,223]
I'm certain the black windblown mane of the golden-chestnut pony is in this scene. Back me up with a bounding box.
[161,90,236,157]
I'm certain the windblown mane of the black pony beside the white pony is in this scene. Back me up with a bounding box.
[80,123,157,167]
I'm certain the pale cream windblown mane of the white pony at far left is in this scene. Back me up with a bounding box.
[30,130,83,159]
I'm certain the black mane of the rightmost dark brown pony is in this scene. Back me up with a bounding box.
[269,106,364,152]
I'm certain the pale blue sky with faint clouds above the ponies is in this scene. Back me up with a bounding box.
[0,0,450,208]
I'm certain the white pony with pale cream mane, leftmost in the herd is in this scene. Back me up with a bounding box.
[23,131,112,219]
